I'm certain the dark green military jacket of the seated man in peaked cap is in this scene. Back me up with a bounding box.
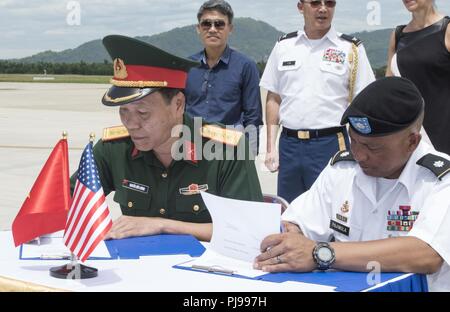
[71,115,263,223]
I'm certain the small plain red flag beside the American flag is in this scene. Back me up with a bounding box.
[12,135,70,247]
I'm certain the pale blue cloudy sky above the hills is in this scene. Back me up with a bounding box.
[0,0,450,59]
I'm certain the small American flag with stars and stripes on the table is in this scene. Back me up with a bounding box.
[64,142,112,262]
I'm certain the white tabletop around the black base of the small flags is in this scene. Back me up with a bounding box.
[0,231,334,292]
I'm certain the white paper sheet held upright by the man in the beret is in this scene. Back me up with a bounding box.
[180,192,281,277]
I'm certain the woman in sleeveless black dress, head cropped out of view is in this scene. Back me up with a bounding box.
[386,0,450,154]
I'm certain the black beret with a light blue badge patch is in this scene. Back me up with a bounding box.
[341,77,424,136]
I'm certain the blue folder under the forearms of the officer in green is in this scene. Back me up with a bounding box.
[105,234,205,259]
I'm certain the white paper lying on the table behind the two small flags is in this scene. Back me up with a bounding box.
[21,231,111,260]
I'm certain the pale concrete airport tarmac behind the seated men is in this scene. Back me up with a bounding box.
[0,83,277,230]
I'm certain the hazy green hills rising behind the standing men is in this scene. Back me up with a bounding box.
[8,18,392,68]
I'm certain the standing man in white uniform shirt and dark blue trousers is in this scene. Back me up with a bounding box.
[260,0,374,202]
